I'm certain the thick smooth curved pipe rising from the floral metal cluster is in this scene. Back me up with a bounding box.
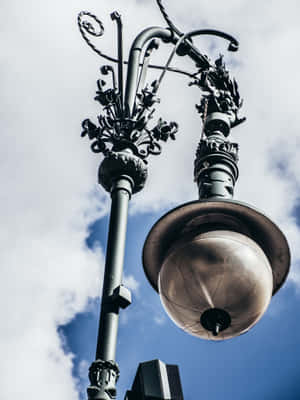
[125,27,173,118]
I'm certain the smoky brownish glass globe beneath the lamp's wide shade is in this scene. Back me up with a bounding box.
[158,230,273,340]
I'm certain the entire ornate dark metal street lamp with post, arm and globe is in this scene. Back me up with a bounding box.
[78,0,290,400]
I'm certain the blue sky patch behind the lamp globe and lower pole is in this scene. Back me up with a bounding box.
[62,214,300,400]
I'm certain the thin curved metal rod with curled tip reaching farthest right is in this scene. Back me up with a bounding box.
[154,29,239,93]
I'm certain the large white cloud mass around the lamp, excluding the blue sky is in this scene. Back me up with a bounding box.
[0,0,300,400]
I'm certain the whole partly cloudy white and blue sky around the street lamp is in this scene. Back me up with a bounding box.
[0,0,300,400]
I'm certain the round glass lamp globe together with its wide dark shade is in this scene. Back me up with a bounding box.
[143,199,290,340]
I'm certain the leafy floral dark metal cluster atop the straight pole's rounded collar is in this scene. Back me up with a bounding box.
[81,66,178,162]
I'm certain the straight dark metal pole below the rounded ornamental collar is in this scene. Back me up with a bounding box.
[87,176,133,400]
